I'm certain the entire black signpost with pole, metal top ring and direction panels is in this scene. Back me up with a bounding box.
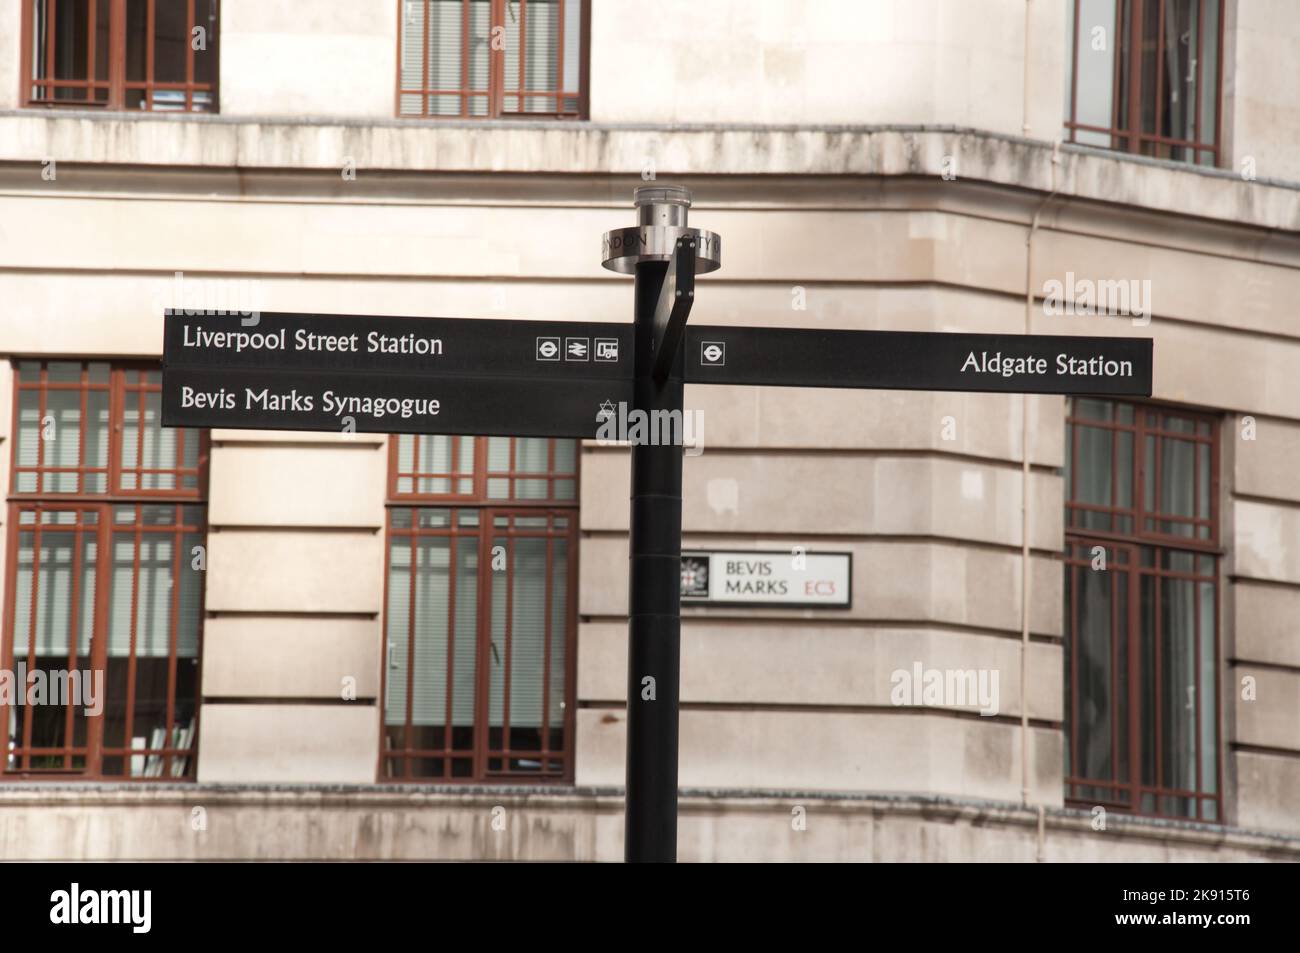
[163,187,1152,861]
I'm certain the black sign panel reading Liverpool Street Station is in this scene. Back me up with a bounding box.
[163,311,632,381]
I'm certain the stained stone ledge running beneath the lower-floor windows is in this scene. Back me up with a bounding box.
[0,784,1300,863]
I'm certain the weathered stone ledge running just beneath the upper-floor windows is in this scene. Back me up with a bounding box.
[0,109,1300,231]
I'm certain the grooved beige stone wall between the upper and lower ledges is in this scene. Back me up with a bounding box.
[0,137,1300,831]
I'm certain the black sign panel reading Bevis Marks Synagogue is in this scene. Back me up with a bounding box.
[163,367,632,438]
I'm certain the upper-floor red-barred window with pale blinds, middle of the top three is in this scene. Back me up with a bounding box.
[398,0,588,118]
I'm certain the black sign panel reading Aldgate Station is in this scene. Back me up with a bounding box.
[685,325,1152,397]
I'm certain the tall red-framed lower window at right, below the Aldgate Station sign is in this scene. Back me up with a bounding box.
[1065,399,1222,822]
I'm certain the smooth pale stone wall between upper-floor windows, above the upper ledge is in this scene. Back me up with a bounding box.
[0,0,1300,182]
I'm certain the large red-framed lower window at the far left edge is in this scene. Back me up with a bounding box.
[0,360,208,780]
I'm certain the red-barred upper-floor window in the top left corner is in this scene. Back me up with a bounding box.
[22,0,217,112]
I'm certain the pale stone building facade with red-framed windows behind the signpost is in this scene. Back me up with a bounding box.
[0,0,1300,861]
